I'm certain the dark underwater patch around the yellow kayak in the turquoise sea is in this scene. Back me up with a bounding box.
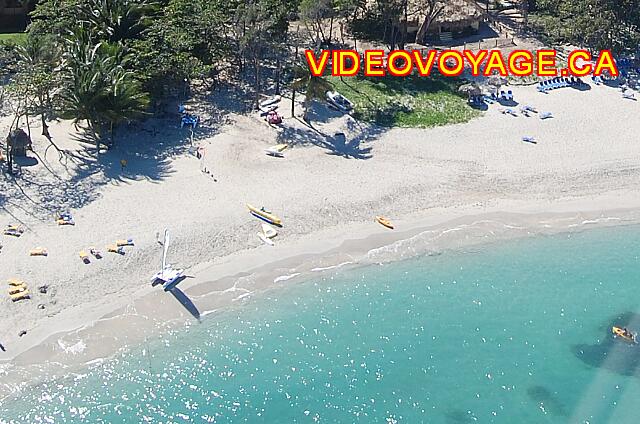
[572,312,640,376]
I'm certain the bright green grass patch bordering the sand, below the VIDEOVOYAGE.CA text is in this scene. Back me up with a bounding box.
[328,76,481,127]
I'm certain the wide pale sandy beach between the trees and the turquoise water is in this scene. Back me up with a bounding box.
[0,82,640,390]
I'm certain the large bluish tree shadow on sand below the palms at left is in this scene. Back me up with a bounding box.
[0,116,222,221]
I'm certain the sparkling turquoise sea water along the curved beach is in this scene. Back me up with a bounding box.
[0,227,640,423]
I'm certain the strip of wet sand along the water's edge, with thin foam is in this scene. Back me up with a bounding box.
[0,192,640,398]
